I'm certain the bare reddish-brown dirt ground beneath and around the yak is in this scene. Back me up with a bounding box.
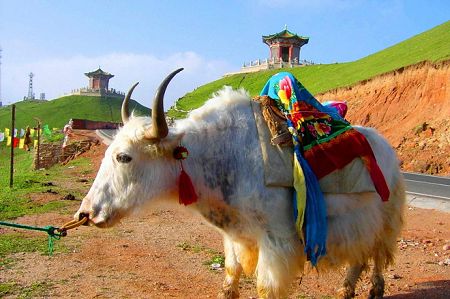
[0,137,450,299]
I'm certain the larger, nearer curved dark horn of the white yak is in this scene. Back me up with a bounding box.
[145,68,183,140]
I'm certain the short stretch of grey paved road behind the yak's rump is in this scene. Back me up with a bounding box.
[403,173,450,201]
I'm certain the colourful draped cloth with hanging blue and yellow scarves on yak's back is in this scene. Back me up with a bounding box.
[260,72,389,265]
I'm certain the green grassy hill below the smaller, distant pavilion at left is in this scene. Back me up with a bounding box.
[0,95,150,131]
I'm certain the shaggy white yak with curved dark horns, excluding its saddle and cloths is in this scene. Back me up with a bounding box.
[74,69,405,298]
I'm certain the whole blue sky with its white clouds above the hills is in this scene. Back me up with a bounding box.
[0,0,450,107]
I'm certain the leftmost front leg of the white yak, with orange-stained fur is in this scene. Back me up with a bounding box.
[218,236,242,299]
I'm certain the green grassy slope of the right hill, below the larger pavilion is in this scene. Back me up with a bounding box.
[169,21,450,118]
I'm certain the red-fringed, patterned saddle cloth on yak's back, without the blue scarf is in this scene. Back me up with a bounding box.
[289,102,390,201]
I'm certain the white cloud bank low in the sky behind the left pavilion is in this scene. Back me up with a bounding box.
[2,52,237,108]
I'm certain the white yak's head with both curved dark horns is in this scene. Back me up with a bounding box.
[74,69,183,227]
